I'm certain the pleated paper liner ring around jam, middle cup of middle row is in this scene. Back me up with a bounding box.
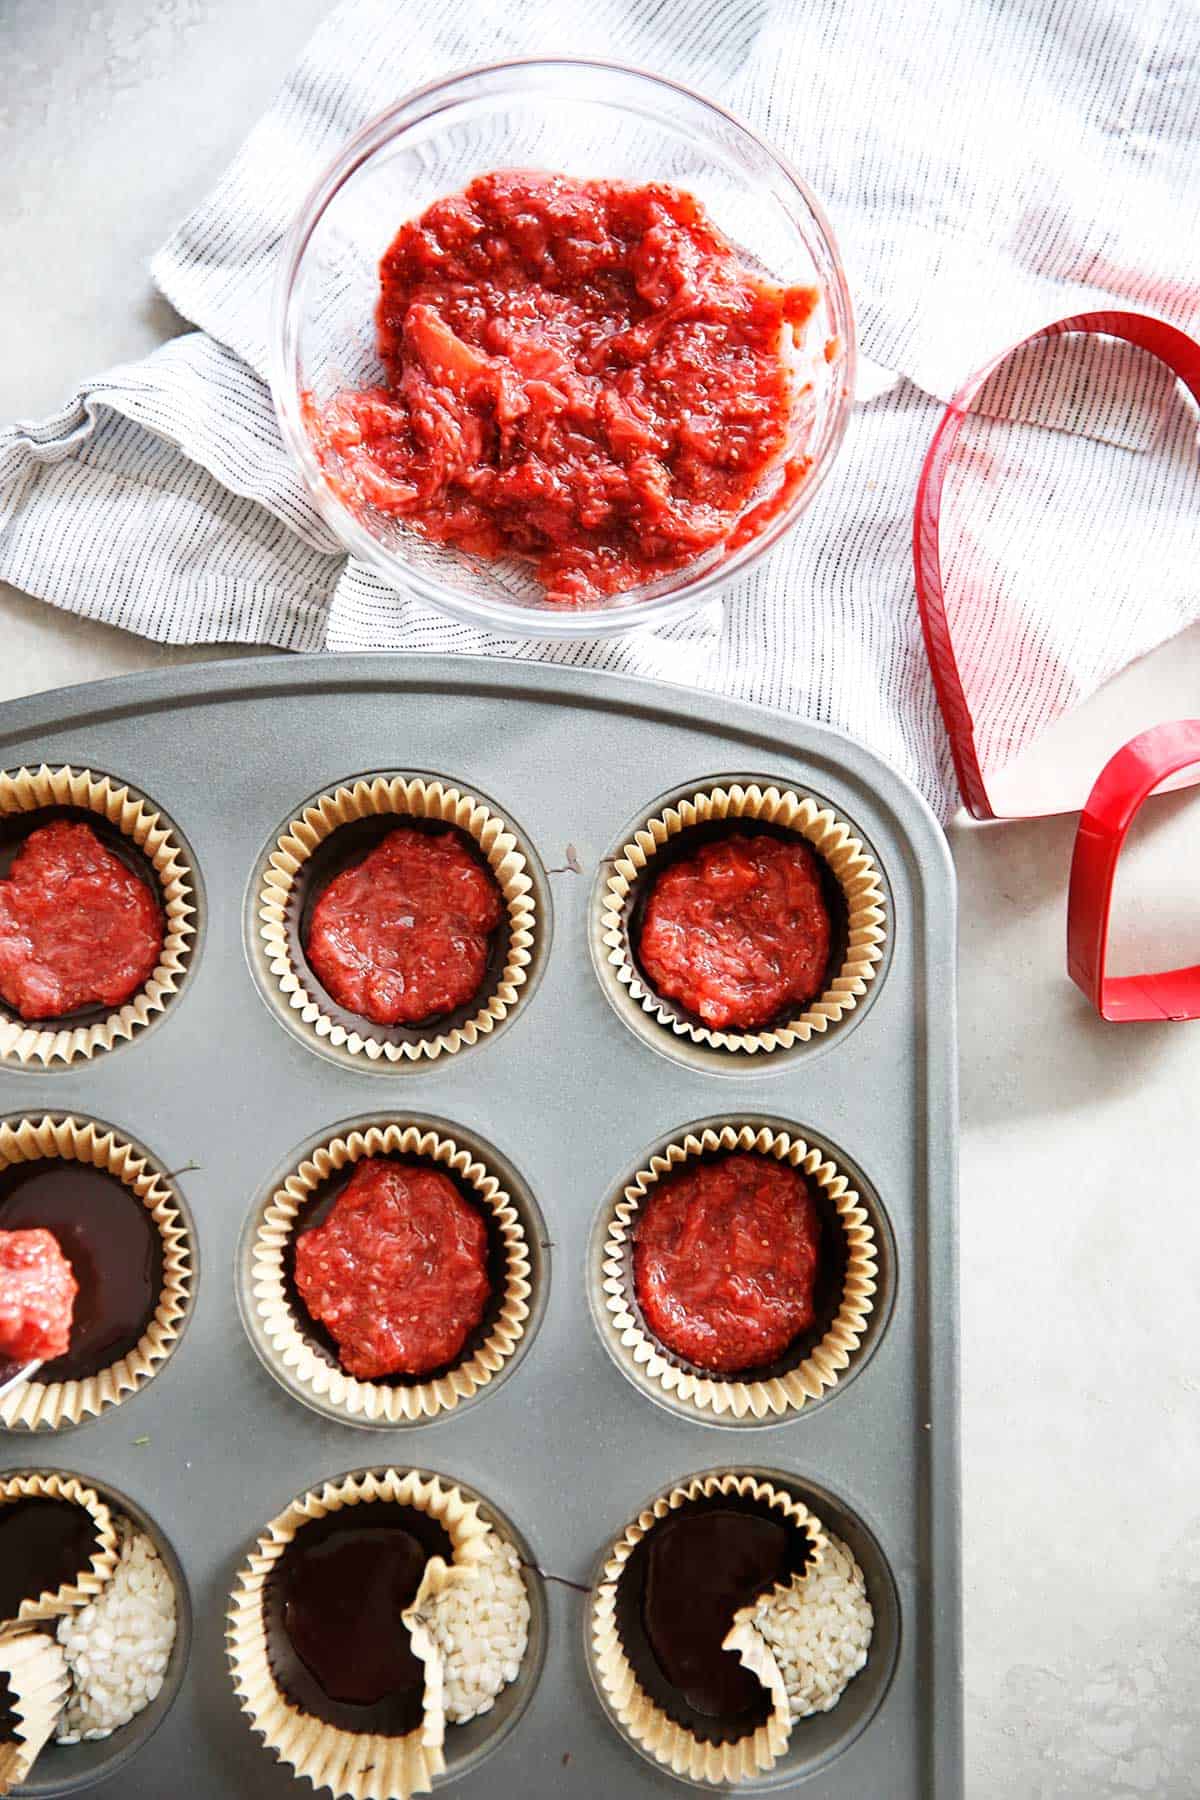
[252,1125,533,1424]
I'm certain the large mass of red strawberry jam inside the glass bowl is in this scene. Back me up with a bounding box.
[304,171,829,607]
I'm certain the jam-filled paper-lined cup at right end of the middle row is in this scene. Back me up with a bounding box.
[590,1118,892,1426]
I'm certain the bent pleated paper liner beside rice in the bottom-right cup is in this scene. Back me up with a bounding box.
[592,1471,826,1786]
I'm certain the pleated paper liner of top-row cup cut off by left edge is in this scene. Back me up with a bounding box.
[0,763,196,1066]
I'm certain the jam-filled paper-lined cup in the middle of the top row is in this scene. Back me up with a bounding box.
[246,772,551,1071]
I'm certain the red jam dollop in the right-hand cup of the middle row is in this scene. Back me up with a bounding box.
[633,1152,820,1375]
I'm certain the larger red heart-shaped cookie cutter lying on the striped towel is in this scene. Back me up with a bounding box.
[912,311,1200,820]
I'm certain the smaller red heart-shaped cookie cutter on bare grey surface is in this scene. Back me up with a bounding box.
[1067,718,1200,1021]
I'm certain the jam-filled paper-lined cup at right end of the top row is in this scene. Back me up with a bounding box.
[590,776,889,1075]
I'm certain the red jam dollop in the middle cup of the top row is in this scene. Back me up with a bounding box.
[304,826,504,1026]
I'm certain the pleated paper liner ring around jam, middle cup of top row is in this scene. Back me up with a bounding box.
[257,776,536,1062]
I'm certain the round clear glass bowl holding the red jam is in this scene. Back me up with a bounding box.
[270,59,855,637]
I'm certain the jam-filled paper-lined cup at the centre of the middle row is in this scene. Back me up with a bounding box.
[237,1118,549,1429]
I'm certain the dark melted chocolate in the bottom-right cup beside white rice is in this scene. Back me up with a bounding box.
[642,1507,806,1726]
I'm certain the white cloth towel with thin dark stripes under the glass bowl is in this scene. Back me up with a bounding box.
[0,0,1200,815]
